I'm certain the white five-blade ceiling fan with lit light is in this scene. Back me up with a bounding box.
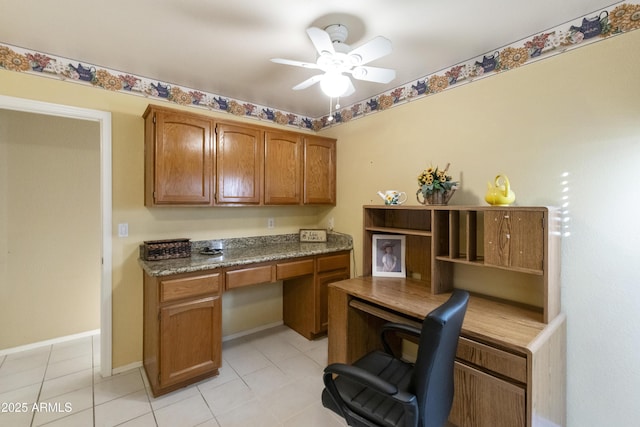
[271,24,396,98]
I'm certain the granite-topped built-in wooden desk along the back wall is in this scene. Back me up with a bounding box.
[140,233,352,396]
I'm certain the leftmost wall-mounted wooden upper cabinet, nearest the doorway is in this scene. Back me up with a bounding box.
[143,107,213,206]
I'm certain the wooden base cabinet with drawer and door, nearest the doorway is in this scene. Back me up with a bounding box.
[143,272,222,396]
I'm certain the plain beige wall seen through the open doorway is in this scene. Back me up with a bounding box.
[0,111,101,349]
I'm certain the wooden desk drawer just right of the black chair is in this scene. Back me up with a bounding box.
[456,337,527,384]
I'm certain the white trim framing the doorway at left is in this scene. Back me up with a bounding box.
[0,95,112,377]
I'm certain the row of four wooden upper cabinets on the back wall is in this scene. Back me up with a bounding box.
[143,105,336,206]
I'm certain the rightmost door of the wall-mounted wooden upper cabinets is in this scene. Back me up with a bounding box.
[304,136,336,205]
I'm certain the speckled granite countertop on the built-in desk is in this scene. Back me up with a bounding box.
[138,232,353,276]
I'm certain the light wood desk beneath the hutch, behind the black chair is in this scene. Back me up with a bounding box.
[328,277,566,427]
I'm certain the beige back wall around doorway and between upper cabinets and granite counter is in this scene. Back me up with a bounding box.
[0,70,327,368]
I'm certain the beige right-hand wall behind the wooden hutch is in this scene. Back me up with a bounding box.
[321,31,640,426]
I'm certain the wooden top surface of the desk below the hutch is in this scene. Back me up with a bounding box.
[329,276,548,354]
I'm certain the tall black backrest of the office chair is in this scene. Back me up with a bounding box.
[412,290,469,427]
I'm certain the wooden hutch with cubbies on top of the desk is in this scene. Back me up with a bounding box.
[363,205,560,323]
